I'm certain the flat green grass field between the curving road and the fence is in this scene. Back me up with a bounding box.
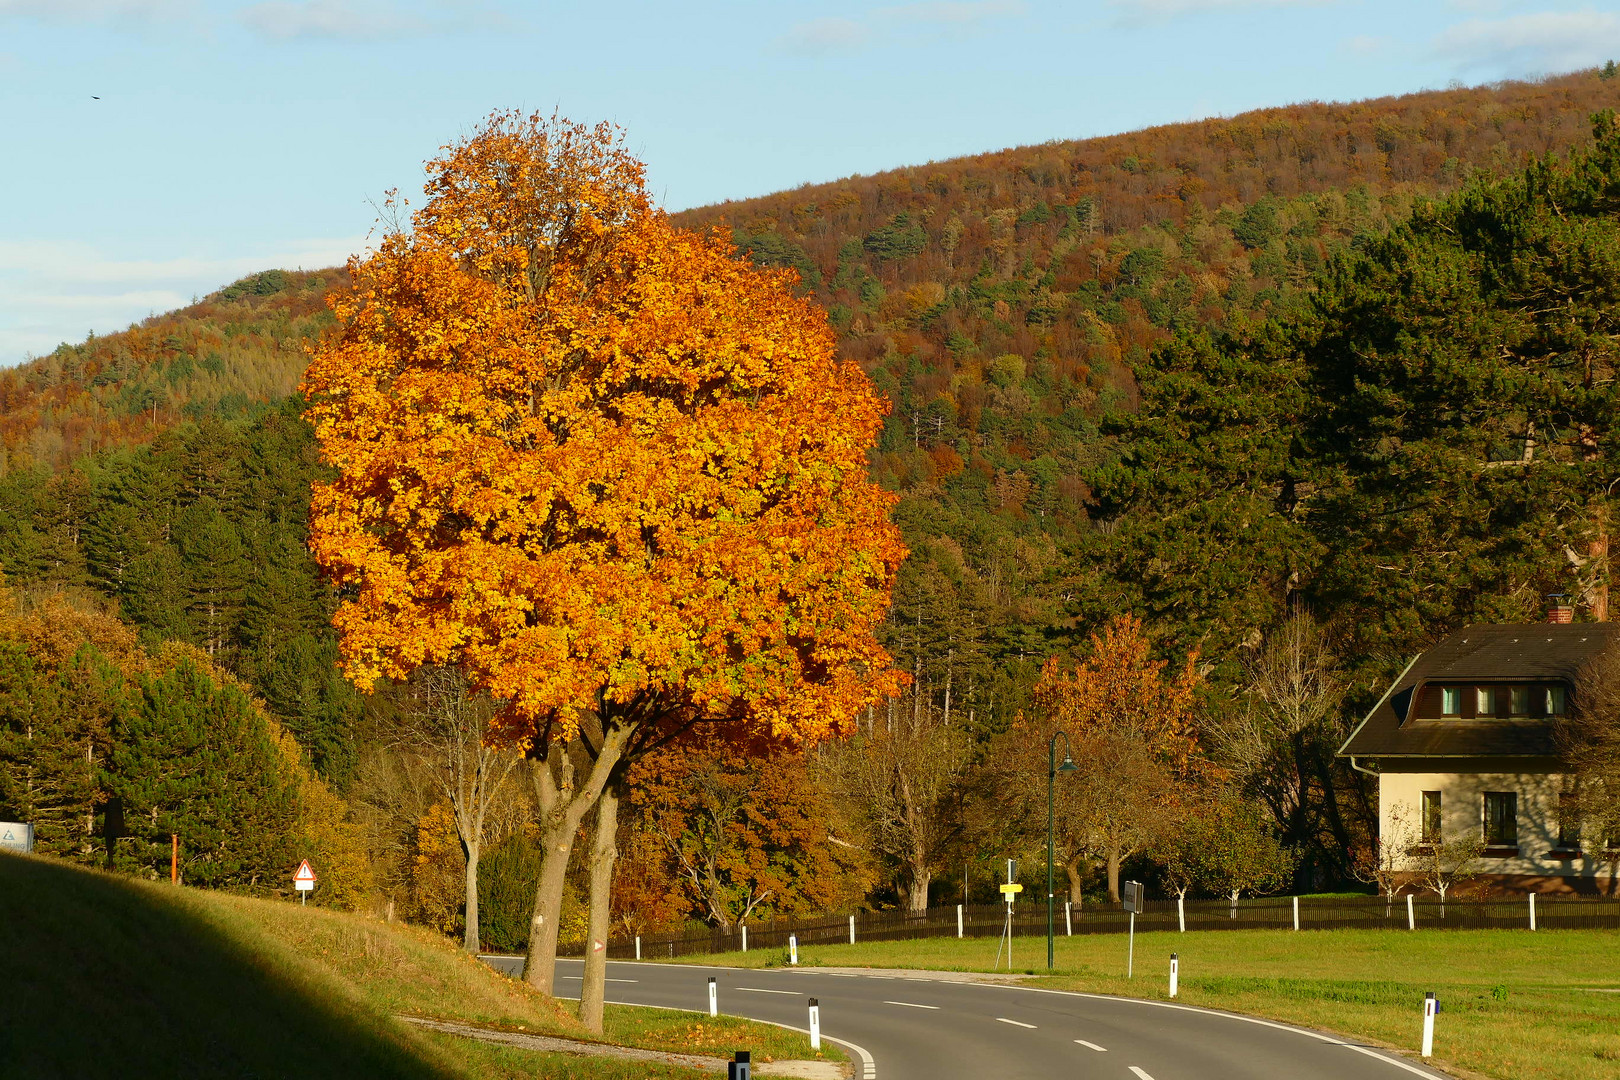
[685,929,1620,1080]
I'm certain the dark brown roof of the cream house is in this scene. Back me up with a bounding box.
[1338,622,1620,758]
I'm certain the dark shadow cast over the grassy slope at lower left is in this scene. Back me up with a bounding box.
[0,855,449,1080]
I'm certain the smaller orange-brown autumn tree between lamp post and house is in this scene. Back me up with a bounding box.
[1001,615,1200,902]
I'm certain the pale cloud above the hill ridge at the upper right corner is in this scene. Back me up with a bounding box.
[1434,10,1620,74]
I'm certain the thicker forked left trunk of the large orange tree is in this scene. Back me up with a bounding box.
[523,725,635,994]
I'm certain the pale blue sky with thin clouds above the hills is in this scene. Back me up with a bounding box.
[0,0,1620,366]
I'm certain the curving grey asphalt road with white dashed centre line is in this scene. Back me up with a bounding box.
[484,957,1443,1080]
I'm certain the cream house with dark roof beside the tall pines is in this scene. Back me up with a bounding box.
[1338,607,1620,892]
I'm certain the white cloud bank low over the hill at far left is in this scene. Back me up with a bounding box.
[0,238,366,366]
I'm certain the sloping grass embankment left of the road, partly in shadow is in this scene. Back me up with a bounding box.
[0,855,836,1080]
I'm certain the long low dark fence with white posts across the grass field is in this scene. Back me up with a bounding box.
[562,894,1620,960]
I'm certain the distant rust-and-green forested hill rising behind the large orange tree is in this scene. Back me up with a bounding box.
[0,71,1620,761]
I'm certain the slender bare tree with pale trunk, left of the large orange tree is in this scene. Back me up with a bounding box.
[399,667,522,954]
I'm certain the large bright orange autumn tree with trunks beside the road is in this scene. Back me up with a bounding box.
[303,113,904,1012]
